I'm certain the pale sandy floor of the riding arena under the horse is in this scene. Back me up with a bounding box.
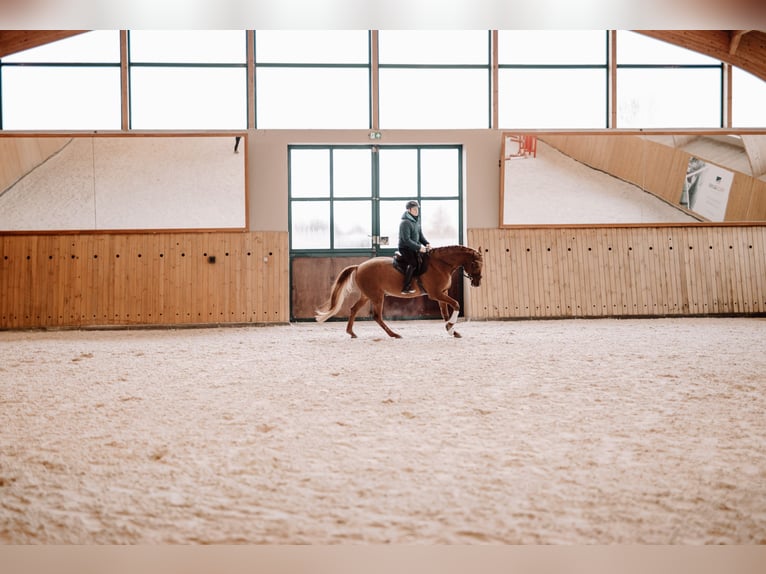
[0,318,766,544]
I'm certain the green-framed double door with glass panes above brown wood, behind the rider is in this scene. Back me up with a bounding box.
[288,145,463,321]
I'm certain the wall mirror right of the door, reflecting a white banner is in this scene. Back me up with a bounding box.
[500,130,766,226]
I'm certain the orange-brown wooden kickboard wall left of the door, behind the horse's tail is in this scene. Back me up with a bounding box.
[0,232,289,328]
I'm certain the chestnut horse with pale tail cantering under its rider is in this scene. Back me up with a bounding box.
[315,245,483,338]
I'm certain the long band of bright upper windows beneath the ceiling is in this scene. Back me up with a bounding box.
[0,30,766,130]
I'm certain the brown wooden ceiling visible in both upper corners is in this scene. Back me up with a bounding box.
[0,30,766,81]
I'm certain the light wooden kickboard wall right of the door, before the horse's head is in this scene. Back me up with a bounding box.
[467,226,766,319]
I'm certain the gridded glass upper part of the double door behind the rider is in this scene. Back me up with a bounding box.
[289,145,462,253]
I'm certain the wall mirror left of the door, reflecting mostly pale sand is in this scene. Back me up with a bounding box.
[0,134,247,231]
